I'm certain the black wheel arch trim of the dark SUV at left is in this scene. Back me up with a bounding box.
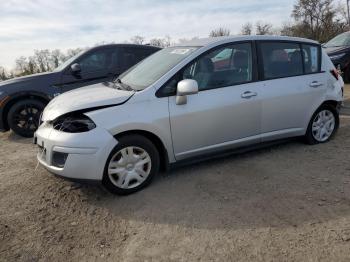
[2,92,50,130]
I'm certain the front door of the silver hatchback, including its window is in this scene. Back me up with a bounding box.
[169,43,261,160]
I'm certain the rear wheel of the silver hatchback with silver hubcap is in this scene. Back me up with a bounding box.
[305,104,339,145]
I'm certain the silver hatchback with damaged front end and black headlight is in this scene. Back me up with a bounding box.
[34,36,344,194]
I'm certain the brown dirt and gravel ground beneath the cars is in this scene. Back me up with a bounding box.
[0,87,350,261]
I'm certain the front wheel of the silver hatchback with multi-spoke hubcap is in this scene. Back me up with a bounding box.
[102,135,160,195]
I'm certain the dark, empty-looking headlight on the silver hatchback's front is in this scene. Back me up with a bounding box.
[52,113,96,133]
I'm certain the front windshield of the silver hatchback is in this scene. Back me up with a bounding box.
[120,47,199,91]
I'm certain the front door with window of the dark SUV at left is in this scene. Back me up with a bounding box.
[61,48,120,92]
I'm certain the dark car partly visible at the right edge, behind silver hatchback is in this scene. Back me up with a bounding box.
[323,32,350,83]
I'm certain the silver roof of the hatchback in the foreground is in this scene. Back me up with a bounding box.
[179,35,318,46]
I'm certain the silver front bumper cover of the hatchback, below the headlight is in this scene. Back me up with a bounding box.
[34,123,117,181]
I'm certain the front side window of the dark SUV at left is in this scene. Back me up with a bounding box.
[79,49,111,73]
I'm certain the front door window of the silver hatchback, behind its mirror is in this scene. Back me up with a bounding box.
[180,43,253,90]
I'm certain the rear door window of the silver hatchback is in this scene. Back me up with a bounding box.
[260,42,303,79]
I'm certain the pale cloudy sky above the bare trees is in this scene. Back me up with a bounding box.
[0,0,295,68]
